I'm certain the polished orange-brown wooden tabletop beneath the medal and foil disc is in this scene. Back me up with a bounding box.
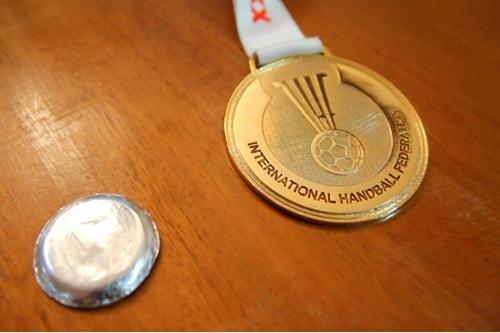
[0,0,500,330]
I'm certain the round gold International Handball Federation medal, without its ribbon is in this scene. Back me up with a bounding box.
[225,55,428,223]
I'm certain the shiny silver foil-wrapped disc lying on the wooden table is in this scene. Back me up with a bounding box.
[33,194,160,308]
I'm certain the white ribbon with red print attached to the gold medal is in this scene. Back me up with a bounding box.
[233,0,323,65]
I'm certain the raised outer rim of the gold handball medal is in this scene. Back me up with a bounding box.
[224,55,429,225]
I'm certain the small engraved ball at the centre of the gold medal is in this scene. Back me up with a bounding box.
[311,130,364,175]
